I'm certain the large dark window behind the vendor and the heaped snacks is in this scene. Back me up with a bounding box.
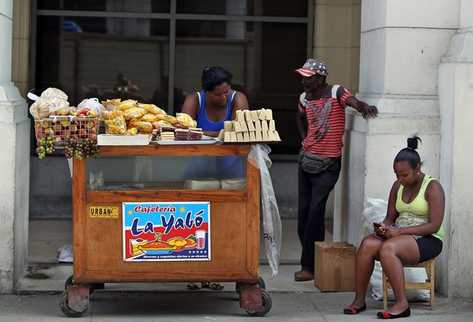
[31,0,313,154]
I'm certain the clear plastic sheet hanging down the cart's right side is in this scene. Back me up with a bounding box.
[248,144,281,278]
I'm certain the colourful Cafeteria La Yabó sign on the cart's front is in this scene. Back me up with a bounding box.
[122,202,211,262]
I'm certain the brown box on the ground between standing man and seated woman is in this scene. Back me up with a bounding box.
[314,242,356,291]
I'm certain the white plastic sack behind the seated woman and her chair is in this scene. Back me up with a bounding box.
[362,199,430,301]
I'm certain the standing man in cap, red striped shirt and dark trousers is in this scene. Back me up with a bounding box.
[294,58,378,281]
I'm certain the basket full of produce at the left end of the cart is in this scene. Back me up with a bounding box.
[34,116,99,147]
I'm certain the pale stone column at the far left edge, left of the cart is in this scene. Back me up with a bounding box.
[0,0,30,293]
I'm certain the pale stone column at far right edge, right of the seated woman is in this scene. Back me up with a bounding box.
[438,0,473,298]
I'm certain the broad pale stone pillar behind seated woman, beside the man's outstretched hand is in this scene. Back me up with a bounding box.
[344,0,459,294]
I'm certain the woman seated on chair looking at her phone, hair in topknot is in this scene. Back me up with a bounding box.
[344,137,445,319]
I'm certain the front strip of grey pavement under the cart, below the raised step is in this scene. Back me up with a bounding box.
[0,290,473,322]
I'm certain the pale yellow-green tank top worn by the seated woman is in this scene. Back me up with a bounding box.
[396,175,445,240]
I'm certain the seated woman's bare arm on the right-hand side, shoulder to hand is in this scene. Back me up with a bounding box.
[399,180,445,236]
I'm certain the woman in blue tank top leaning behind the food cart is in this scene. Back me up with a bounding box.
[182,67,248,179]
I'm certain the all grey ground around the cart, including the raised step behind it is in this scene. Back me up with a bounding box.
[0,265,473,322]
